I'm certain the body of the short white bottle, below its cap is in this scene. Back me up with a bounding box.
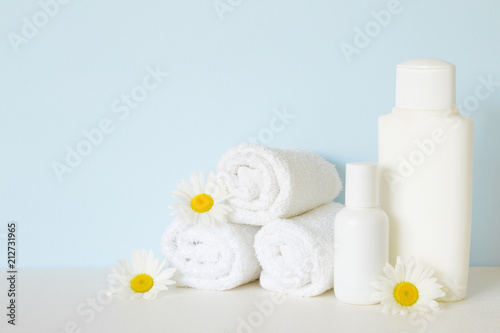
[333,207,389,305]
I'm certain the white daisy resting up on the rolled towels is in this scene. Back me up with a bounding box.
[169,172,232,225]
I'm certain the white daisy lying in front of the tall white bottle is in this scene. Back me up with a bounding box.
[372,257,445,315]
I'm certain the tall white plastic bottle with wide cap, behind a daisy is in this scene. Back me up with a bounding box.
[378,58,473,301]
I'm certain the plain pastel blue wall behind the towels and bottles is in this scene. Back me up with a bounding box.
[0,0,500,267]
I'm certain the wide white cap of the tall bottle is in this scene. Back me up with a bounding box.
[396,58,455,110]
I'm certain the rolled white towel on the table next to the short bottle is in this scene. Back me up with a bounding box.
[254,202,344,296]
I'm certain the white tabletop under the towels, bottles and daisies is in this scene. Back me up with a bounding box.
[0,267,500,333]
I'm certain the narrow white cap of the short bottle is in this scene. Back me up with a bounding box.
[345,162,378,208]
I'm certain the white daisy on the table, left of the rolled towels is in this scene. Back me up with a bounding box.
[108,249,175,300]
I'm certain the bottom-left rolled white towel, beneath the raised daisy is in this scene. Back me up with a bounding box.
[161,217,261,290]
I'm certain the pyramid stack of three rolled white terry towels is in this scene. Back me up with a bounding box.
[162,143,343,296]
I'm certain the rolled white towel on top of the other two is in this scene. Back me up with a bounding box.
[217,143,342,225]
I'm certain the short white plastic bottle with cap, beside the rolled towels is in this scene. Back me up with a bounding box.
[333,162,389,305]
